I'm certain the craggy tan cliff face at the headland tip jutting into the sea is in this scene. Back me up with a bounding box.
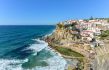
[47,23,80,43]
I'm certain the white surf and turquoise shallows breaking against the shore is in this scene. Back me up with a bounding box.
[0,39,66,70]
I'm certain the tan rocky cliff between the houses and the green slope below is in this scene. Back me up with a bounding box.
[45,22,93,70]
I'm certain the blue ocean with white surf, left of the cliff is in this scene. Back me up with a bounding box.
[0,25,66,70]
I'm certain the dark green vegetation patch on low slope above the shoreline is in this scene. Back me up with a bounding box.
[55,46,84,70]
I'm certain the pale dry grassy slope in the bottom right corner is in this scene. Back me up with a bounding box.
[92,41,109,70]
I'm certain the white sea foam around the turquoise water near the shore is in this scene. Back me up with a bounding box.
[0,39,66,70]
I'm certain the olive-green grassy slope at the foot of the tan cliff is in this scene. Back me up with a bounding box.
[49,44,84,70]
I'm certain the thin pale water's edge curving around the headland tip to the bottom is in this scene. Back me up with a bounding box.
[44,28,83,70]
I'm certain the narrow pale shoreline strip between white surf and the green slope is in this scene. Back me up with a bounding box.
[48,43,84,70]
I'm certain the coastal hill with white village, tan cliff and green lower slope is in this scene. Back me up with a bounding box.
[45,19,109,70]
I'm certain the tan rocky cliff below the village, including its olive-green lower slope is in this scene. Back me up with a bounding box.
[45,22,93,70]
